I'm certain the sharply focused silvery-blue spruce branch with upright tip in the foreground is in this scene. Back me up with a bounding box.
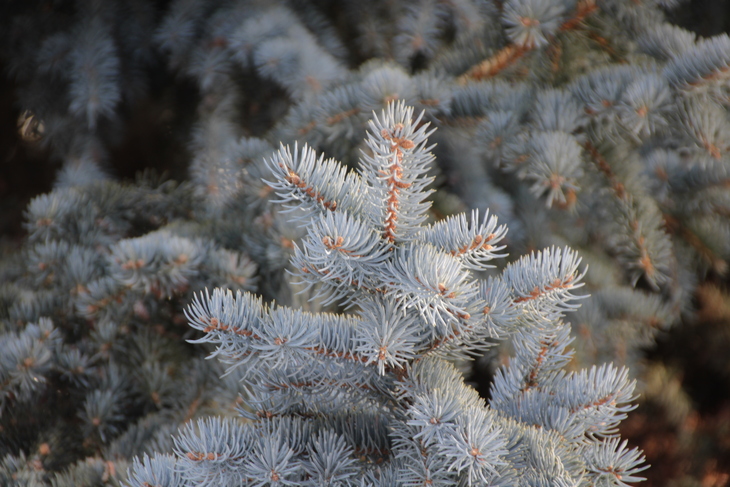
[129,103,647,486]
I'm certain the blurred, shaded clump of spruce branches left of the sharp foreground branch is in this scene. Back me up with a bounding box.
[0,175,256,487]
